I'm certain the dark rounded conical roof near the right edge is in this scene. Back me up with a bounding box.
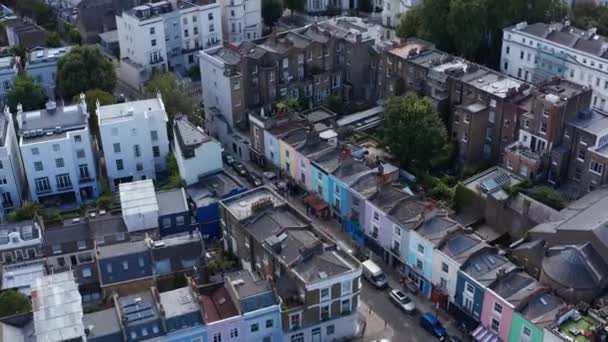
[543,246,601,289]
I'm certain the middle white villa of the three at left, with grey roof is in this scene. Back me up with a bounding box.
[17,95,99,206]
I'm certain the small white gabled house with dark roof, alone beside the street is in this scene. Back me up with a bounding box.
[173,116,223,185]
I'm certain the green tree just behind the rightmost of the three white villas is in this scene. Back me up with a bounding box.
[146,72,198,120]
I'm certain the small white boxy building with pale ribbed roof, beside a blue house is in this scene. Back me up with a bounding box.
[118,179,158,233]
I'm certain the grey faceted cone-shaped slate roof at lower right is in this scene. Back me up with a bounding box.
[543,243,608,289]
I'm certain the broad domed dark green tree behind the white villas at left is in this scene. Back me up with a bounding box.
[57,46,116,99]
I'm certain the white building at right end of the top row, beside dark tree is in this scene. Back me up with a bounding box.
[221,0,262,43]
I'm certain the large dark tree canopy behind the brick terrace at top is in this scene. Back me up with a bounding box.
[397,0,567,66]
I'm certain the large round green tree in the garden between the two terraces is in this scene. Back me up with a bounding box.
[382,93,447,169]
